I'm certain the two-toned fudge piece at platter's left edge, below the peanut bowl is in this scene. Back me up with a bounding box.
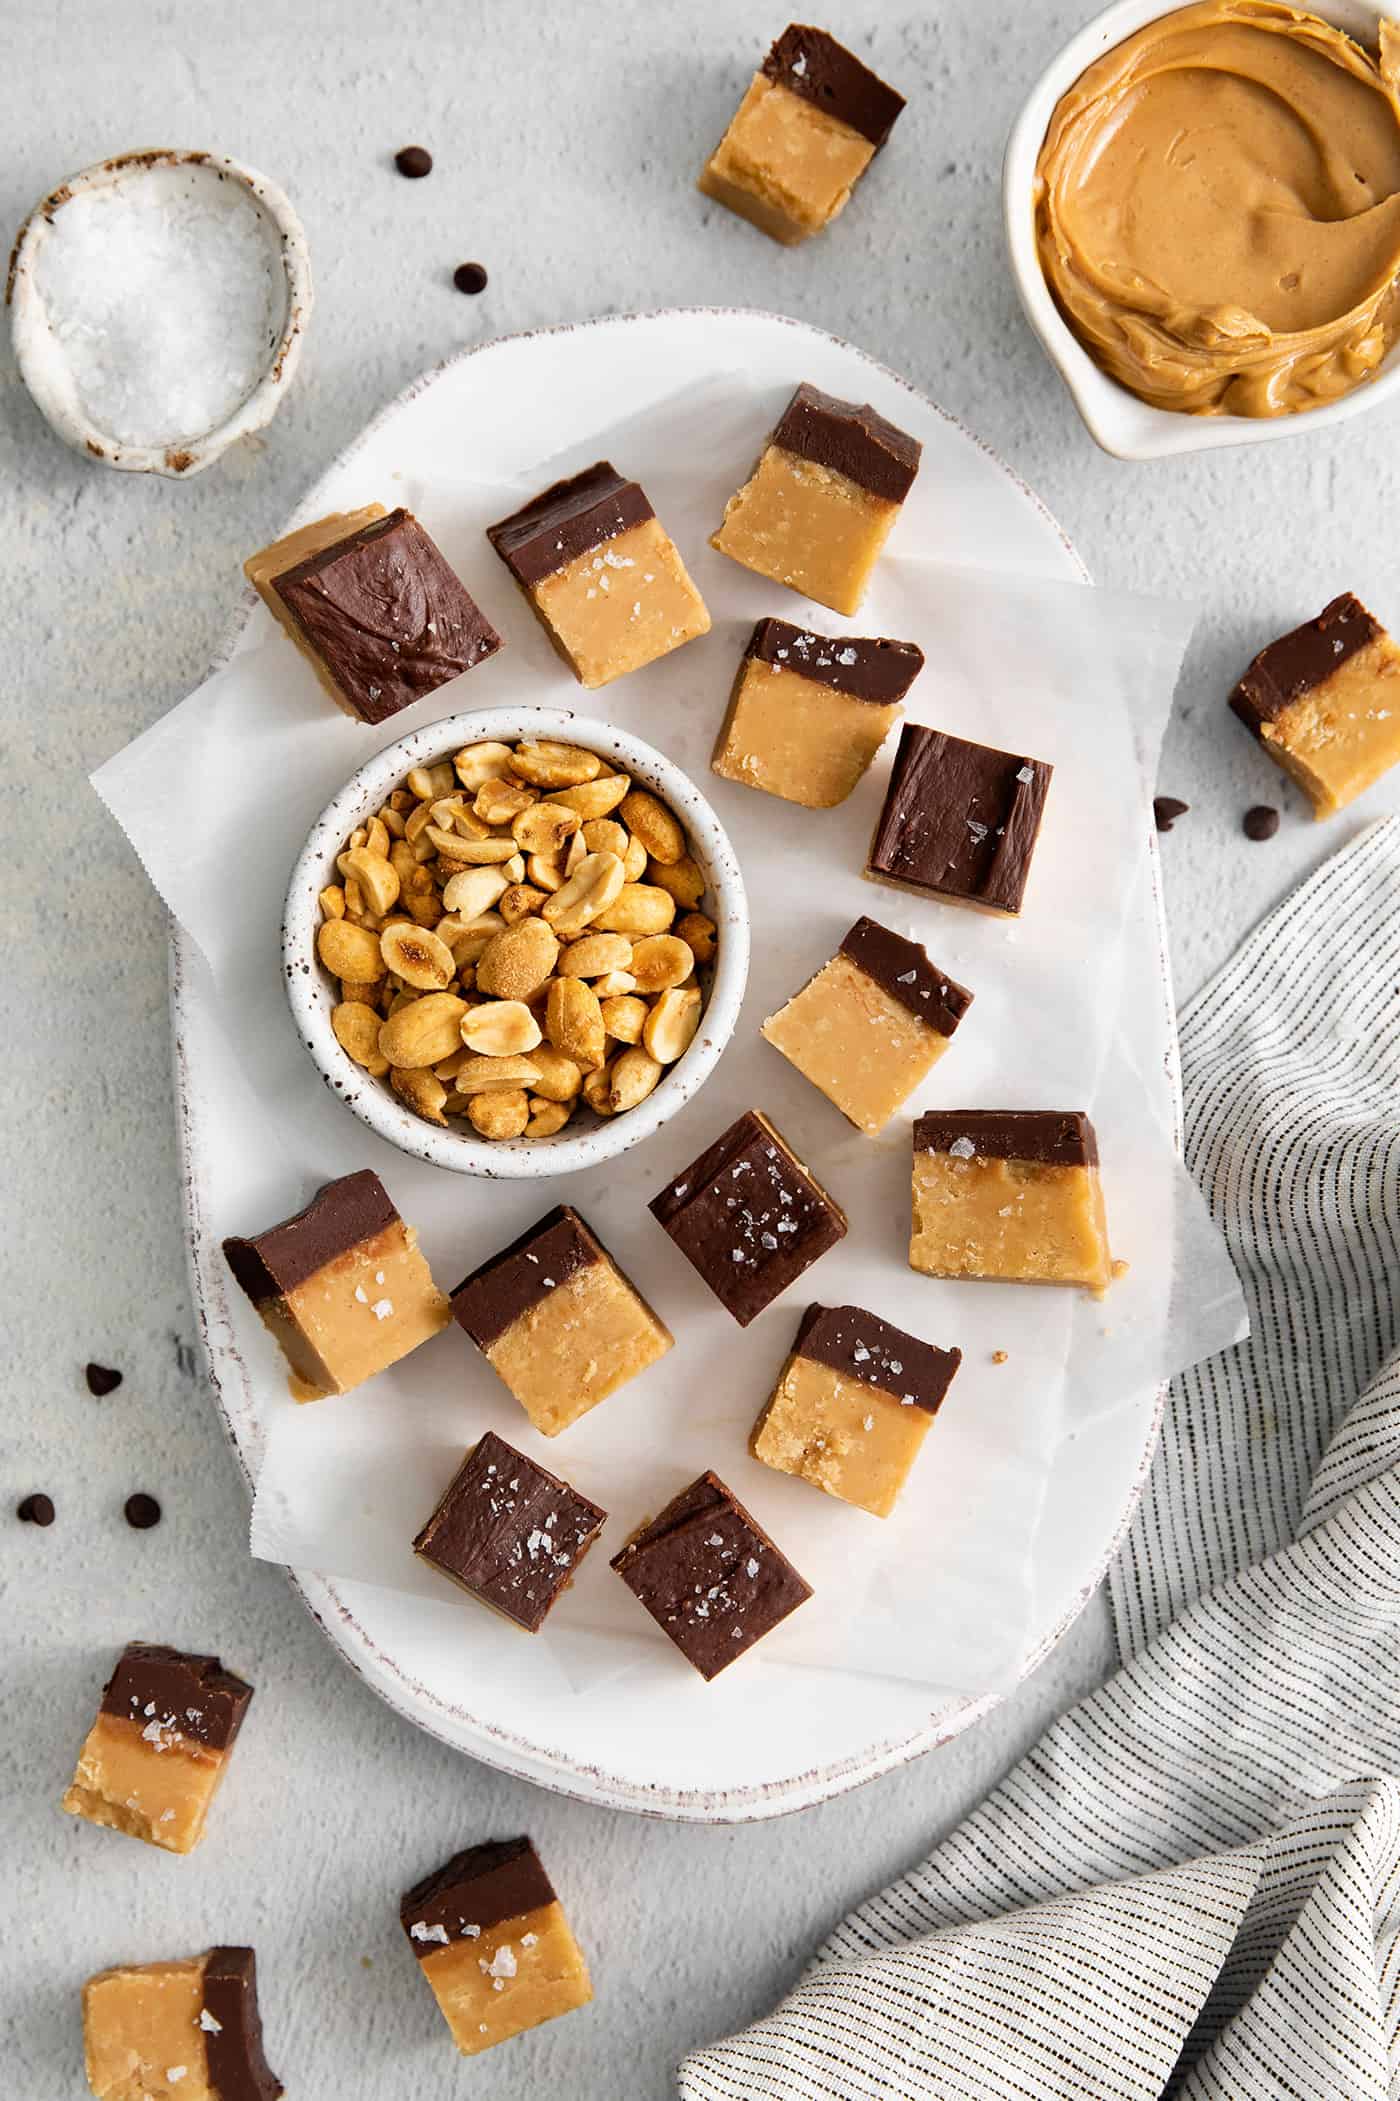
[223,1168,452,1401]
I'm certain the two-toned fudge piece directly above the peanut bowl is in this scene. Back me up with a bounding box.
[488,460,711,687]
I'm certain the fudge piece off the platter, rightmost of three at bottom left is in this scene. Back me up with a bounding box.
[399,1838,593,2057]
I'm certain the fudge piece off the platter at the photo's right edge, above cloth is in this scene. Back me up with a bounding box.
[1230,590,1400,817]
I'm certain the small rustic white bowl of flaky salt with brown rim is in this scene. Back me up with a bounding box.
[6,151,311,479]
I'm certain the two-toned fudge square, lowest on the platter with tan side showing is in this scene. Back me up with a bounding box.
[748,1307,963,1517]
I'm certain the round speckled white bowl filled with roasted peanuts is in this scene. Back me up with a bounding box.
[282,708,748,1179]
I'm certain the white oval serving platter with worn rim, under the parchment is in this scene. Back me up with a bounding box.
[172,309,1179,1824]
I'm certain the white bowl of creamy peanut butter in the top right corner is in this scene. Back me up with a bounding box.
[1003,0,1400,460]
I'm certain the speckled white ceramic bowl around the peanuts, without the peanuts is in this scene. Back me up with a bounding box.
[282,708,748,1181]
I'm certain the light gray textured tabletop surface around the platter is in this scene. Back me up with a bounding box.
[0,0,1400,2101]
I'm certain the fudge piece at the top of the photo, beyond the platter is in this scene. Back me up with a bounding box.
[700,21,904,248]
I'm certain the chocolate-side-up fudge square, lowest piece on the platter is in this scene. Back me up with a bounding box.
[612,1473,811,1679]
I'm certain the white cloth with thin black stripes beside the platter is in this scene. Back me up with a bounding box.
[679,819,1400,2101]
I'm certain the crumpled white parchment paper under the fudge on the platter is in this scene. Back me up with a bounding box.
[95,374,1242,1693]
